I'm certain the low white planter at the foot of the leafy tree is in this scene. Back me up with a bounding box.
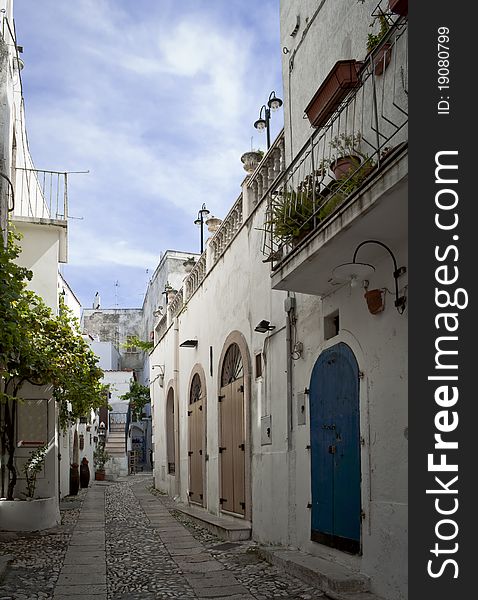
[0,498,61,531]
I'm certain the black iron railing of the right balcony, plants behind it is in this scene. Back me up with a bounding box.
[263,19,408,269]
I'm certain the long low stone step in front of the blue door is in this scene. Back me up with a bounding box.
[255,546,372,600]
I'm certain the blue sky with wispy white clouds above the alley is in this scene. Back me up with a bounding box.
[15,0,283,308]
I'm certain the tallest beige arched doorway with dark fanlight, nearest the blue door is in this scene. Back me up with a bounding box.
[219,343,246,516]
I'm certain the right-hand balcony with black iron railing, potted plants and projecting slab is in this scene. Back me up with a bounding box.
[263,18,408,295]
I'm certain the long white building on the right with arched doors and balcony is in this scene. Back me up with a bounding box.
[150,1,408,600]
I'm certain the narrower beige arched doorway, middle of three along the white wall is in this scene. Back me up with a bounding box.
[188,373,206,505]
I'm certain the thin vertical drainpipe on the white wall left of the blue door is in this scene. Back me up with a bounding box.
[284,292,297,546]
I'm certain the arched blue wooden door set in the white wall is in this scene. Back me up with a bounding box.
[309,343,361,554]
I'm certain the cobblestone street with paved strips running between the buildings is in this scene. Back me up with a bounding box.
[0,474,323,600]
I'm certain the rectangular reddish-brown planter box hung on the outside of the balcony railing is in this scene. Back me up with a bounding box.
[305,60,362,127]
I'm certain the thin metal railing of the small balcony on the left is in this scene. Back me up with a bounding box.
[14,167,68,221]
